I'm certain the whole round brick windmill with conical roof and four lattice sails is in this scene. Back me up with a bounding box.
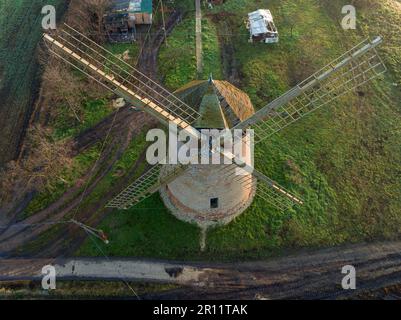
[44,25,386,226]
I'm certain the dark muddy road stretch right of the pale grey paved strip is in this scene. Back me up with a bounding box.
[146,242,401,299]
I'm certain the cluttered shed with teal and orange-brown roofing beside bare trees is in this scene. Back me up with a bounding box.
[104,0,153,34]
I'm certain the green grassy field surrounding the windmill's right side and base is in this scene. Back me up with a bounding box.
[79,0,401,260]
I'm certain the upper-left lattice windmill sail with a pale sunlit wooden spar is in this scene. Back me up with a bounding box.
[44,24,199,128]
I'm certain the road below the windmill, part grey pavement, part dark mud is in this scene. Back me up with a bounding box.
[0,241,401,299]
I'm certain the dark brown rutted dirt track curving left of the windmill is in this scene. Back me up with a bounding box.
[0,107,156,256]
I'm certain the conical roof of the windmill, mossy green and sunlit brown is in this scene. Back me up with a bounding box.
[175,79,255,129]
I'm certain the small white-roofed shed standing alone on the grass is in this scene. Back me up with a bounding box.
[247,9,279,43]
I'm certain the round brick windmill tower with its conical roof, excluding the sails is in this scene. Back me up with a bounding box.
[160,78,256,228]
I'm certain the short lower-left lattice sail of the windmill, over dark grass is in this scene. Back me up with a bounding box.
[106,164,187,210]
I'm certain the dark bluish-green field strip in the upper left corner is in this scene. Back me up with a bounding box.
[0,0,64,164]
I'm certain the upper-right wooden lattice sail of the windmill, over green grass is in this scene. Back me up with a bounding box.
[235,37,386,143]
